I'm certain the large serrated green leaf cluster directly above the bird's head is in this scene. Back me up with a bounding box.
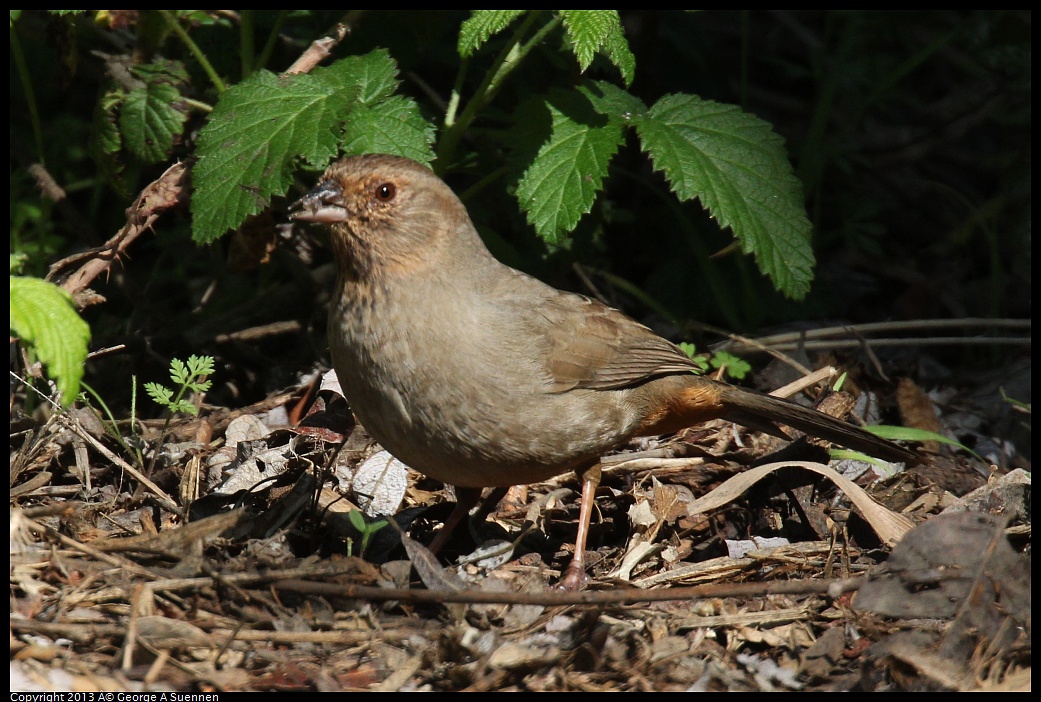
[192,50,433,244]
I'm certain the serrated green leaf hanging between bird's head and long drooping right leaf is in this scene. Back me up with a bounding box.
[516,83,643,243]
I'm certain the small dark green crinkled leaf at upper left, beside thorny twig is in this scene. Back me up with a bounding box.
[120,82,187,164]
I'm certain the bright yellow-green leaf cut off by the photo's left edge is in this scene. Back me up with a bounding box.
[10,276,91,406]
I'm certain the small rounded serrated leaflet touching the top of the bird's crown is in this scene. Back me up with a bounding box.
[344,95,434,164]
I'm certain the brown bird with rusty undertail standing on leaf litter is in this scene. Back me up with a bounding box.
[291,154,914,588]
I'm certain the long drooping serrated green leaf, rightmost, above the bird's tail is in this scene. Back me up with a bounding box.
[634,95,814,299]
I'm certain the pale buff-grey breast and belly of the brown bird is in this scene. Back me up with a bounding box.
[329,281,637,486]
